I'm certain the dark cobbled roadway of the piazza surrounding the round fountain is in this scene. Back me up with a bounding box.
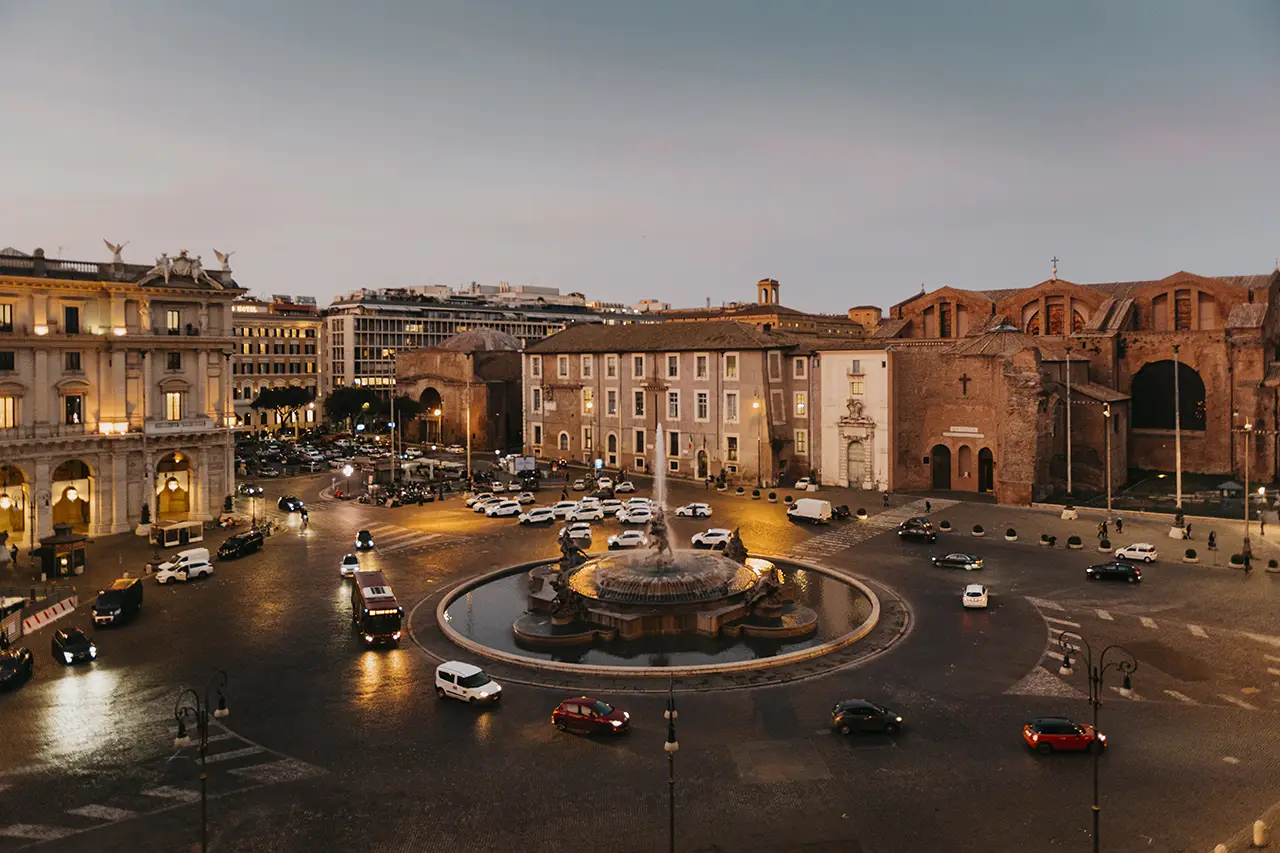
[0,475,1280,853]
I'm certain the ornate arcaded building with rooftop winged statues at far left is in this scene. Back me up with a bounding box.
[0,246,243,547]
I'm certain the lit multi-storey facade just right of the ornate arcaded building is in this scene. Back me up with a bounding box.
[232,296,324,432]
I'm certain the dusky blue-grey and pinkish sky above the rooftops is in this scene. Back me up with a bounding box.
[0,0,1280,313]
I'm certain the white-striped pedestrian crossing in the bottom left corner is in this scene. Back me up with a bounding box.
[0,720,318,852]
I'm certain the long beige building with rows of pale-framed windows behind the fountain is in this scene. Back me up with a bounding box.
[522,320,815,485]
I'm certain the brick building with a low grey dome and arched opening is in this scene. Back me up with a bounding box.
[396,329,521,451]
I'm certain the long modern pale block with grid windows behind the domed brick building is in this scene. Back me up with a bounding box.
[321,284,611,392]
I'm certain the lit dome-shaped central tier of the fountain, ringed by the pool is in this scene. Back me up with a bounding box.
[568,551,772,605]
